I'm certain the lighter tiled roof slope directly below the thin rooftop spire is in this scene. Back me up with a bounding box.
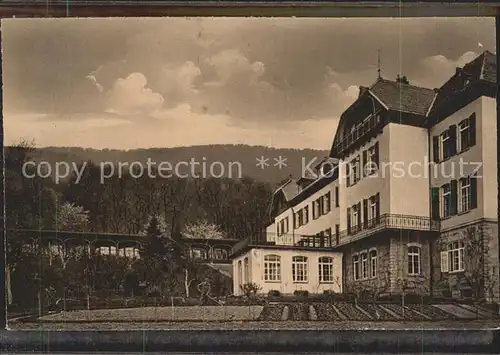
[369,78,436,116]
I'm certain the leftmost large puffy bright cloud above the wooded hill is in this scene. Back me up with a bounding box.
[107,73,163,115]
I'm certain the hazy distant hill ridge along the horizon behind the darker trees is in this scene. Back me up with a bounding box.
[10,145,328,184]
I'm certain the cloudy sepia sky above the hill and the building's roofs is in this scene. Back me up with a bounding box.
[1,18,496,149]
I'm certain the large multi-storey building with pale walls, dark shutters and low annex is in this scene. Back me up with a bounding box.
[233,51,500,298]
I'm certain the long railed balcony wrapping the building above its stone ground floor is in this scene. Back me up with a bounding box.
[335,214,440,246]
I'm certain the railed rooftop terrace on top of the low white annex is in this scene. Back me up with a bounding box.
[232,232,335,254]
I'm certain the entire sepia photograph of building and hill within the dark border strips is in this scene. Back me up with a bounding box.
[1,17,500,331]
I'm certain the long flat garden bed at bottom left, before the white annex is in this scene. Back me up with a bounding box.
[40,306,263,322]
